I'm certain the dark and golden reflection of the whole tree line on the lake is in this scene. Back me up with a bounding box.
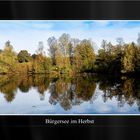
[0,74,140,111]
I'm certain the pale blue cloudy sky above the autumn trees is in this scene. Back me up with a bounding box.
[0,20,140,53]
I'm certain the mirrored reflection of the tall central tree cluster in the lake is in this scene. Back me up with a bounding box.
[49,77,96,110]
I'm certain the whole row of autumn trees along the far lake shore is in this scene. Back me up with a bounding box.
[0,33,140,75]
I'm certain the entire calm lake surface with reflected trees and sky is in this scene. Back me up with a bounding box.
[0,75,140,114]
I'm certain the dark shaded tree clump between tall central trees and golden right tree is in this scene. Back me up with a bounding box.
[94,40,122,74]
